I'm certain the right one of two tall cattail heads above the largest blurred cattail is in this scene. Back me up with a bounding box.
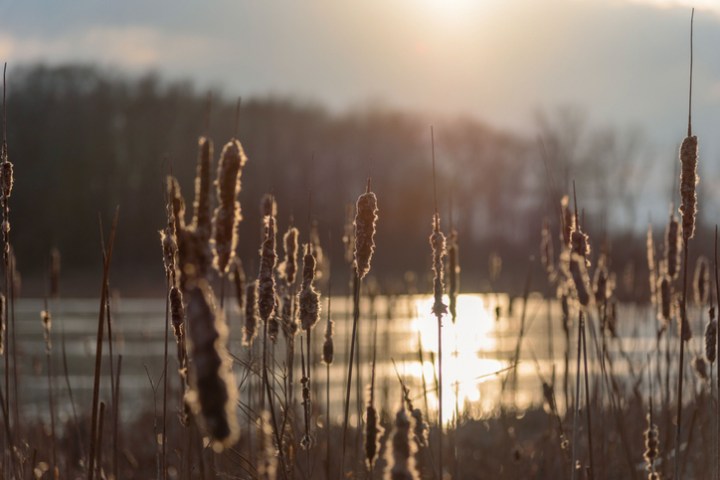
[213,139,247,275]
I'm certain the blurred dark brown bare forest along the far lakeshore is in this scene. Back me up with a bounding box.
[2,65,660,295]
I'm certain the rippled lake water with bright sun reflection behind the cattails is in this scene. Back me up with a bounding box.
[5,295,702,428]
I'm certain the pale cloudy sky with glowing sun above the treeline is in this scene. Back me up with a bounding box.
[0,0,720,223]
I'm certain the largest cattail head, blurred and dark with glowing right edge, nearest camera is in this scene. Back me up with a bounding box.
[186,279,240,453]
